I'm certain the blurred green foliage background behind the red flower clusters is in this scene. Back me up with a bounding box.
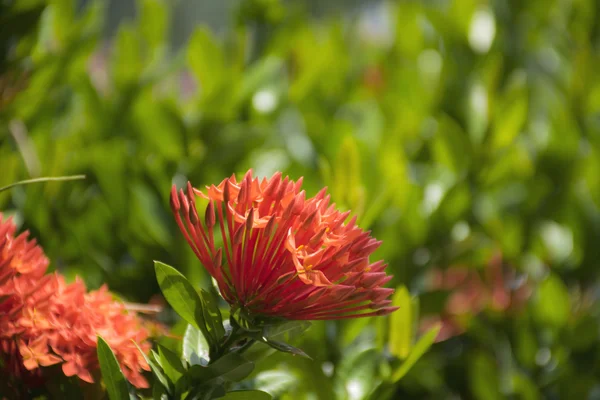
[0,0,600,400]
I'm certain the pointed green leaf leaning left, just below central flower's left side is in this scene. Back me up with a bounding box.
[154,261,210,340]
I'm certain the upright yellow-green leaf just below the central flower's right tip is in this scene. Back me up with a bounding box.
[389,286,413,360]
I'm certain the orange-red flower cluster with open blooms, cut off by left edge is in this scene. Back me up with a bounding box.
[0,214,151,387]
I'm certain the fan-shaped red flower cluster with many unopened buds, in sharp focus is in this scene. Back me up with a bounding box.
[171,170,396,320]
